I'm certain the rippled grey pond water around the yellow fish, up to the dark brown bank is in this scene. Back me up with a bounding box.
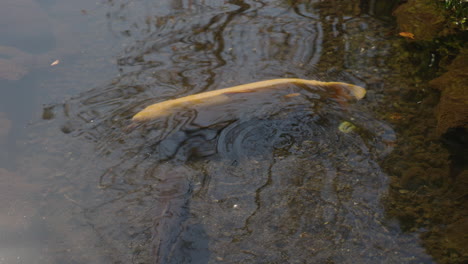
[0,0,460,263]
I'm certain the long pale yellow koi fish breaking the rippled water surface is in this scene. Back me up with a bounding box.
[132,78,366,122]
